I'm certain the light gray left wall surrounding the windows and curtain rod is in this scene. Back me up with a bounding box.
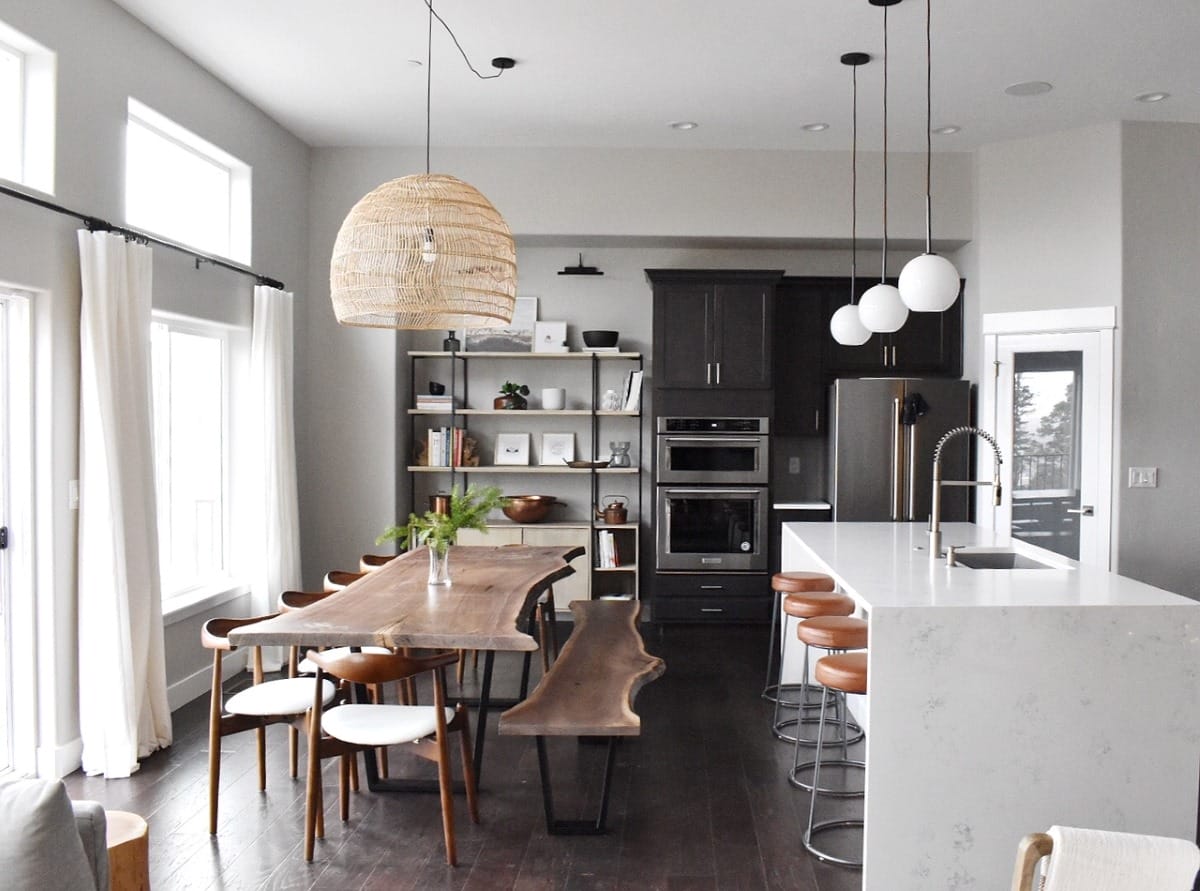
[0,0,308,772]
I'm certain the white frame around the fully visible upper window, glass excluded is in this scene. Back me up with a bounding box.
[125,96,253,267]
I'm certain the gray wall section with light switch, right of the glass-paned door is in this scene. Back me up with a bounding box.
[1116,122,1200,599]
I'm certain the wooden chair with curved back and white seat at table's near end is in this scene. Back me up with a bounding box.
[304,650,479,866]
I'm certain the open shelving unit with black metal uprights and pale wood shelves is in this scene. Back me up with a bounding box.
[407,351,646,611]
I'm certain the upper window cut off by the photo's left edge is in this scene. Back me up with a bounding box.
[0,22,55,192]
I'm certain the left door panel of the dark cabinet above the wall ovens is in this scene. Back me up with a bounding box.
[654,282,713,388]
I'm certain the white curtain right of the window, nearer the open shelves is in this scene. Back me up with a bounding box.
[247,285,300,668]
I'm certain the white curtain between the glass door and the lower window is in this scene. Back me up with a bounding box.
[78,231,172,778]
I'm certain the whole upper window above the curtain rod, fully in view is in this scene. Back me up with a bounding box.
[125,98,250,264]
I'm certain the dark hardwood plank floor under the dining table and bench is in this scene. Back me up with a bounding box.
[66,626,862,891]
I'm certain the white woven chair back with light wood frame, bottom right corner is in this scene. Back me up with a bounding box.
[1013,826,1200,891]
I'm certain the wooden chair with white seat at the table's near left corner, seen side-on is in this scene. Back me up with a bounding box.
[200,614,336,835]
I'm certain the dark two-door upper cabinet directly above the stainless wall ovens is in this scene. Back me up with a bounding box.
[646,269,782,389]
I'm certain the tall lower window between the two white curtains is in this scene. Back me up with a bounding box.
[150,317,229,599]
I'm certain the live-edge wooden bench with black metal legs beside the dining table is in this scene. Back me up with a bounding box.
[500,600,666,836]
